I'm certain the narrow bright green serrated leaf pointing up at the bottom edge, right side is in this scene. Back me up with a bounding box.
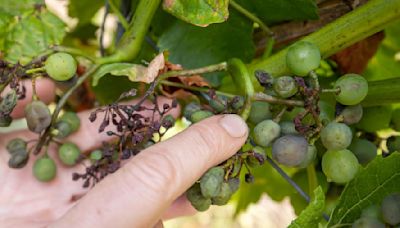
[289,186,325,228]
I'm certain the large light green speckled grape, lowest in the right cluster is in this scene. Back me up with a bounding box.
[322,149,359,184]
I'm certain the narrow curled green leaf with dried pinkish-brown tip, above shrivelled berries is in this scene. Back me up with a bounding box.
[92,53,165,86]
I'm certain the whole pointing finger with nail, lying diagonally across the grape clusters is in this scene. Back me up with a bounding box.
[55,114,248,227]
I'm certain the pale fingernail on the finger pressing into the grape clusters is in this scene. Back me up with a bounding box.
[219,114,248,138]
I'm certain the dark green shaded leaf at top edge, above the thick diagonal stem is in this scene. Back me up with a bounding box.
[231,0,319,24]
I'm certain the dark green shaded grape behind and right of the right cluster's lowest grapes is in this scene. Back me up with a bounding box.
[349,139,378,165]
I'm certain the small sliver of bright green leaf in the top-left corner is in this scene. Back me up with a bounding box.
[0,0,45,16]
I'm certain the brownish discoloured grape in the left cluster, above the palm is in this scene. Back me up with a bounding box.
[25,101,51,133]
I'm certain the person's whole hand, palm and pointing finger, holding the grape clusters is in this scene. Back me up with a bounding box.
[0,78,248,227]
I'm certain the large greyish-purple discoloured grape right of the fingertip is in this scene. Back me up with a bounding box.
[272,135,308,167]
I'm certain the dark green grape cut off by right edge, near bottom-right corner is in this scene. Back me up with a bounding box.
[381,193,400,226]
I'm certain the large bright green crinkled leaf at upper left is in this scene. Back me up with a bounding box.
[4,9,65,64]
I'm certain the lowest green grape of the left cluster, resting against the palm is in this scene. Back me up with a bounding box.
[33,157,57,182]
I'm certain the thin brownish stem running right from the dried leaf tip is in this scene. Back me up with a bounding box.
[157,62,227,81]
